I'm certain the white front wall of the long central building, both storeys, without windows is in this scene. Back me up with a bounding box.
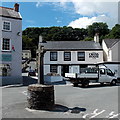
[44,50,103,75]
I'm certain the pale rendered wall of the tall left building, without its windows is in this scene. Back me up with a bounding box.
[0,17,22,84]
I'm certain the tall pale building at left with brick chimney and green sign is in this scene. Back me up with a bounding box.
[0,3,22,85]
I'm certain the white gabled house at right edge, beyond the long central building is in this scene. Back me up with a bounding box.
[102,39,120,62]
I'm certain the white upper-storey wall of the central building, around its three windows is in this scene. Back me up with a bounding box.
[44,50,103,65]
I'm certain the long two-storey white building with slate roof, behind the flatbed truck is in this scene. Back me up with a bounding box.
[43,41,103,76]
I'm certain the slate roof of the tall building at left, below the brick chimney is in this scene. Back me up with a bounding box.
[0,7,22,20]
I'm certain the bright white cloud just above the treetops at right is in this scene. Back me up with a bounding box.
[68,15,114,28]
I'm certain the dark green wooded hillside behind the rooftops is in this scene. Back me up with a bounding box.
[23,22,120,57]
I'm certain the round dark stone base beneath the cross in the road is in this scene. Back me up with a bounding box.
[27,84,55,110]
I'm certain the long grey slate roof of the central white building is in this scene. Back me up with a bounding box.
[44,41,102,50]
